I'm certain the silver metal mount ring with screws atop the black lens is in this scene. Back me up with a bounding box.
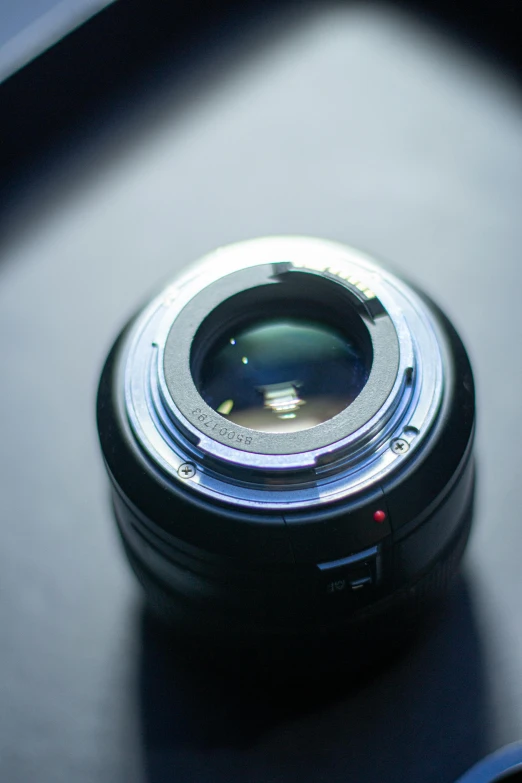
[125,237,444,510]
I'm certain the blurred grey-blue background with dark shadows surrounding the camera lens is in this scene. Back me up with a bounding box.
[0,0,522,783]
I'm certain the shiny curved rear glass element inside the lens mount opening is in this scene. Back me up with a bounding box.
[196,318,371,432]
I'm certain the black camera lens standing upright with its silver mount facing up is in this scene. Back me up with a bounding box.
[97,237,475,647]
